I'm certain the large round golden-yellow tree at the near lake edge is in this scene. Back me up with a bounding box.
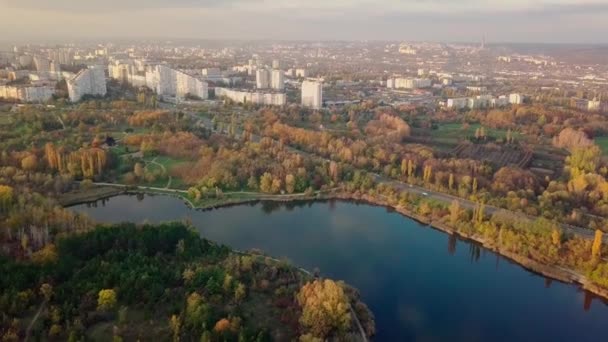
[297,279,351,338]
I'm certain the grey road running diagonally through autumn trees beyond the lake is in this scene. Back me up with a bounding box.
[186,112,608,241]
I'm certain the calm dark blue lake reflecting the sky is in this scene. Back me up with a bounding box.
[72,195,608,341]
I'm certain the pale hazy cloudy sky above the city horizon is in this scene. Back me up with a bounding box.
[0,0,608,43]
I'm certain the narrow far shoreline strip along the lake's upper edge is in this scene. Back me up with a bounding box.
[63,189,608,301]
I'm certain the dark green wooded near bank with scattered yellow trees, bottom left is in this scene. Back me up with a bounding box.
[0,223,373,341]
